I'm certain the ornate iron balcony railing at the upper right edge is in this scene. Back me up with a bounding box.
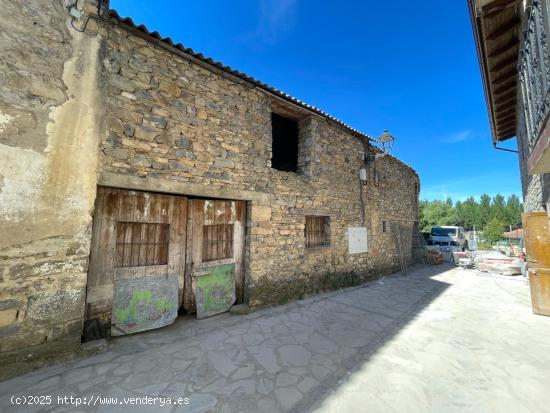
[519,0,550,153]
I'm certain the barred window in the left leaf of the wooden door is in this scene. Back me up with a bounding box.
[115,222,170,268]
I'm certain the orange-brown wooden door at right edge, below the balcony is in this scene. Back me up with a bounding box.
[523,211,550,316]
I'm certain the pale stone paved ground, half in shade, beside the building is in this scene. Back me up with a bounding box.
[0,266,550,413]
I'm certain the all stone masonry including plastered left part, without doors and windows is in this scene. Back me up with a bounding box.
[0,0,419,376]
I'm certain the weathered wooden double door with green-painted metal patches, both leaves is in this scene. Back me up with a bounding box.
[86,187,245,336]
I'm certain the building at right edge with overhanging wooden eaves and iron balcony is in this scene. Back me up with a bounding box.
[468,0,550,315]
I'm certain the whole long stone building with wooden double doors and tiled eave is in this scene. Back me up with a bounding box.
[0,0,419,375]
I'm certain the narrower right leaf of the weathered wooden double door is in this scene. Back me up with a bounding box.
[183,199,245,319]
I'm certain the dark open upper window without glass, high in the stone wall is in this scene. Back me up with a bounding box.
[271,113,298,172]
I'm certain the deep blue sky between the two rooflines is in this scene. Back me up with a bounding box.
[111,0,521,200]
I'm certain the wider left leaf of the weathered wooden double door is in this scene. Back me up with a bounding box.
[86,187,187,336]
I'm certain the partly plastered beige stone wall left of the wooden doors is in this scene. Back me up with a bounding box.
[0,0,103,376]
